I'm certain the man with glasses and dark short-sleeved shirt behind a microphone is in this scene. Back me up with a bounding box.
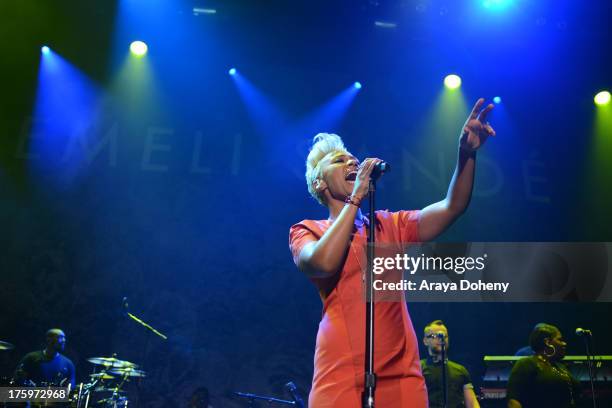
[421,320,480,408]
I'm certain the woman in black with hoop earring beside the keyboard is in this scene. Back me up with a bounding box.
[508,323,580,408]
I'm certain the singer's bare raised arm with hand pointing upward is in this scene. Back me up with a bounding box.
[419,98,495,241]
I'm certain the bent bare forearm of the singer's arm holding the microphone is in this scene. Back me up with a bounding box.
[298,204,358,278]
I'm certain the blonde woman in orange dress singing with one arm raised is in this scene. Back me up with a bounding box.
[289,99,495,408]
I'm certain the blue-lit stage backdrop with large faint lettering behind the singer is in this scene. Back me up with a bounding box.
[0,1,612,407]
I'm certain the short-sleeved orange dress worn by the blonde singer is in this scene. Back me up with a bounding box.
[289,211,428,408]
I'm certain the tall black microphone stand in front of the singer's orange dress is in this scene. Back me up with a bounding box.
[361,177,376,408]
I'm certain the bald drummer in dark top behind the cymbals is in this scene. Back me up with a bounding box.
[14,329,75,389]
